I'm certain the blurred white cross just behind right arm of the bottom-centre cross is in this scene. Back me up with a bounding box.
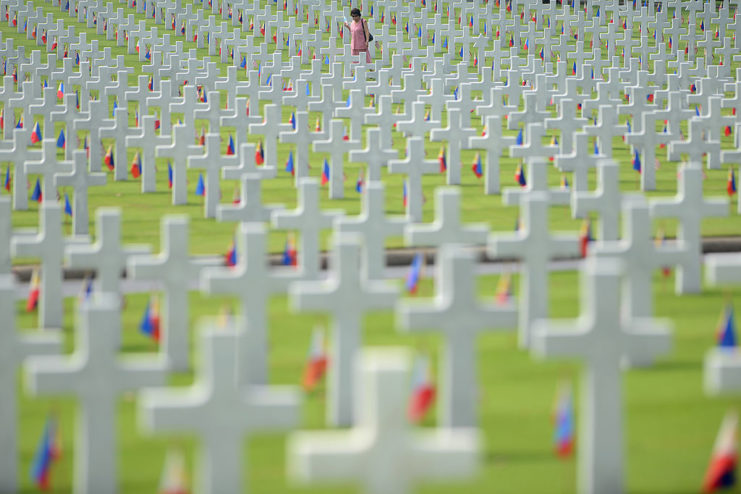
[397,245,517,427]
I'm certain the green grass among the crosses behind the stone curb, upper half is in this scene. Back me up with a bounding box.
[0,4,741,263]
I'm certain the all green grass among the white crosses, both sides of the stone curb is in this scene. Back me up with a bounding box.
[0,3,741,494]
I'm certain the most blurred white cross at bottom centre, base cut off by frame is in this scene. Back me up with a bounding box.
[288,349,481,494]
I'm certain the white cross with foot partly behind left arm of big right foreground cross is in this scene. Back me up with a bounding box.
[488,192,579,348]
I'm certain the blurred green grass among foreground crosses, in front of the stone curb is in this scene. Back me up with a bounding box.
[10,272,741,494]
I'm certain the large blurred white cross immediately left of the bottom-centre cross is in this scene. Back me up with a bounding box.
[140,320,300,493]
